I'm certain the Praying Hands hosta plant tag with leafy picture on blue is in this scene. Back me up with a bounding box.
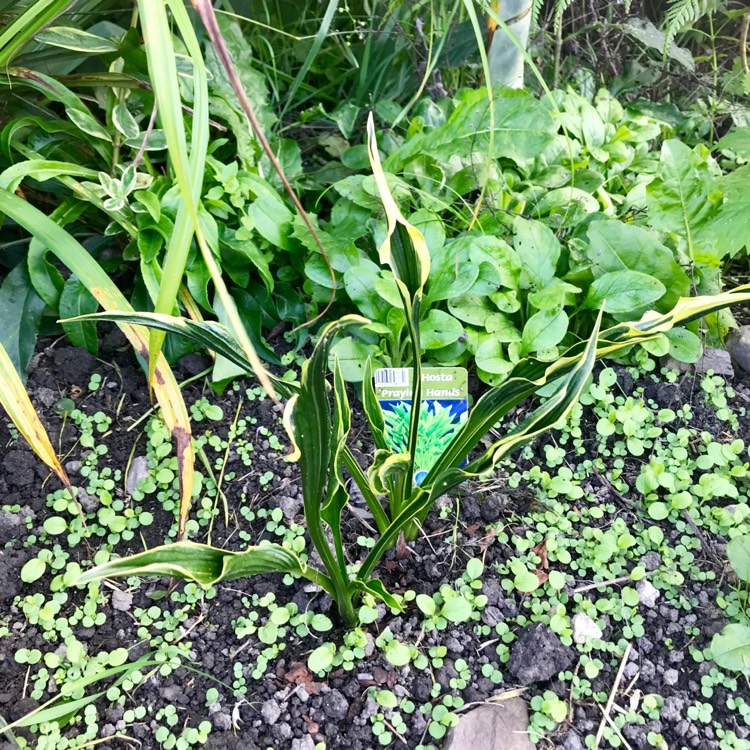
[374,367,469,484]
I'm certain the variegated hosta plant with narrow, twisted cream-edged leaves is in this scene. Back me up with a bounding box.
[72,117,750,625]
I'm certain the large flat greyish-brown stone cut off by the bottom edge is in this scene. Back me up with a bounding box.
[445,698,534,750]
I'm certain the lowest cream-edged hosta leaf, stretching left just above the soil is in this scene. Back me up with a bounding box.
[73,541,330,589]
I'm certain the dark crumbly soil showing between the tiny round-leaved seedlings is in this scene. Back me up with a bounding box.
[0,332,750,750]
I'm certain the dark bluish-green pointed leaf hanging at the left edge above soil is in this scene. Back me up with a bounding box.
[0,263,44,382]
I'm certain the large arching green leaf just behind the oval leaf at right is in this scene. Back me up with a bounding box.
[586,220,690,312]
